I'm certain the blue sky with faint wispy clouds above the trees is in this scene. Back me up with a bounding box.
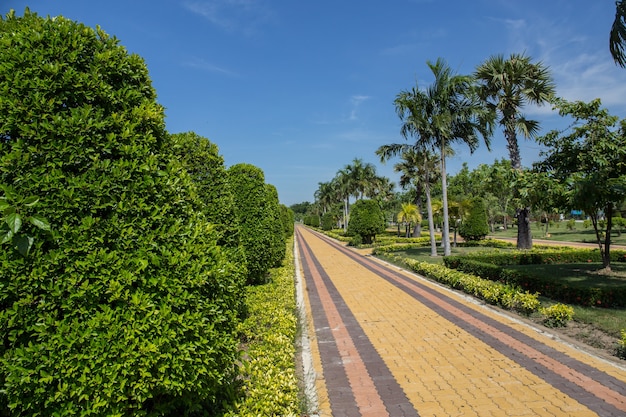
[0,0,626,205]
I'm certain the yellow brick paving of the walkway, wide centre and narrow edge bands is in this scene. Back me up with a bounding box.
[298,228,626,417]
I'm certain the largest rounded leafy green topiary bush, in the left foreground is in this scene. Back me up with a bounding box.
[0,10,243,416]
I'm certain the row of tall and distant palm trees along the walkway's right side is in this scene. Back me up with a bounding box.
[315,54,555,255]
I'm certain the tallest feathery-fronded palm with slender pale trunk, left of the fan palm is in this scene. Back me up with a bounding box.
[394,58,492,256]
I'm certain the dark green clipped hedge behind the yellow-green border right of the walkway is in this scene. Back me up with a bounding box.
[444,256,626,308]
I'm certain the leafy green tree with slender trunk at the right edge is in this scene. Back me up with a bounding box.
[537,99,626,270]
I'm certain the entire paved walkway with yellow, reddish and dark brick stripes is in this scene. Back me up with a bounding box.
[296,226,626,417]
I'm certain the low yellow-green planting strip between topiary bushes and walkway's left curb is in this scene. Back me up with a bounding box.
[225,238,301,417]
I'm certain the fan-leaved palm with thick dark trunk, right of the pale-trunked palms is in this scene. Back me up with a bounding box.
[474,54,555,249]
